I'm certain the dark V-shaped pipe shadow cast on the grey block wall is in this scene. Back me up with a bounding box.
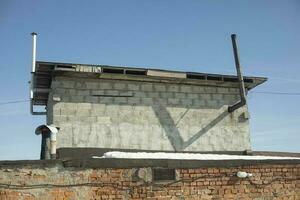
[152,104,229,151]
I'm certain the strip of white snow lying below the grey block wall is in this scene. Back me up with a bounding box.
[93,151,300,160]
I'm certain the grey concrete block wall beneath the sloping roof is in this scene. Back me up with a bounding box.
[47,76,250,151]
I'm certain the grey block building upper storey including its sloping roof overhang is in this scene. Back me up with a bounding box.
[33,62,266,151]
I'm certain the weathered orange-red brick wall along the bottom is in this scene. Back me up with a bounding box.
[0,164,300,200]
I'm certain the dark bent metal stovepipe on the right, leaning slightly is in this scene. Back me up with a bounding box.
[228,34,247,113]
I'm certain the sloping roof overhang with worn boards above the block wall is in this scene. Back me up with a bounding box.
[33,61,267,105]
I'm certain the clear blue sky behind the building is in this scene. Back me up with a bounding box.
[0,0,300,160]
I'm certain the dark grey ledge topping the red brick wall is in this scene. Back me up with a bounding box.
[0,158,300,169]
